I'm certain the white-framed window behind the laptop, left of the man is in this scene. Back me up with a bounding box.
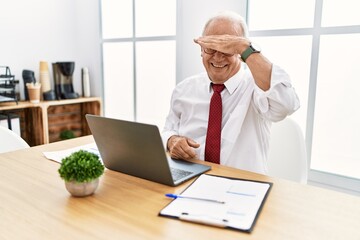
[101,0,176,129]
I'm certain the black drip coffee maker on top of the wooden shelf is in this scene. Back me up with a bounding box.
[52,62,79,100]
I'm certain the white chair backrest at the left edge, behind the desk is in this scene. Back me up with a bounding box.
[0,126,30,153]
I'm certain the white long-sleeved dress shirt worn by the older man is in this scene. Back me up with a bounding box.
[162,64,299,174]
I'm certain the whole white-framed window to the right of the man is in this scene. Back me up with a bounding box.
[248,0,360,191]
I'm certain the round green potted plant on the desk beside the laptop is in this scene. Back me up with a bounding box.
[58,150,104,197]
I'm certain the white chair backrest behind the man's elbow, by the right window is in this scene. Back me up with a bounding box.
[268,118,308,183]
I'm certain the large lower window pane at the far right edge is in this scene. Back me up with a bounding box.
[311,33,360,178]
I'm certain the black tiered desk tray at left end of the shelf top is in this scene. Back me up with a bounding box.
[0,66,19,104]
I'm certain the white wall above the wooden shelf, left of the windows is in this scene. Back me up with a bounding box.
[0,0,102,98]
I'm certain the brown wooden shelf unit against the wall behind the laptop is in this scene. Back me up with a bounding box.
[0,97,102,146]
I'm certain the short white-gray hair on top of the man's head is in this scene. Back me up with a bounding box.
[202,11,249,38]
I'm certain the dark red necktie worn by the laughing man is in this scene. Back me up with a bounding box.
[205,84,225,164]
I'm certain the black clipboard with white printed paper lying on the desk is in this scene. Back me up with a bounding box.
[159,174,272,232]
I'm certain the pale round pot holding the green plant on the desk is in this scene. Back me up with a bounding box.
[65,178,99,197]
